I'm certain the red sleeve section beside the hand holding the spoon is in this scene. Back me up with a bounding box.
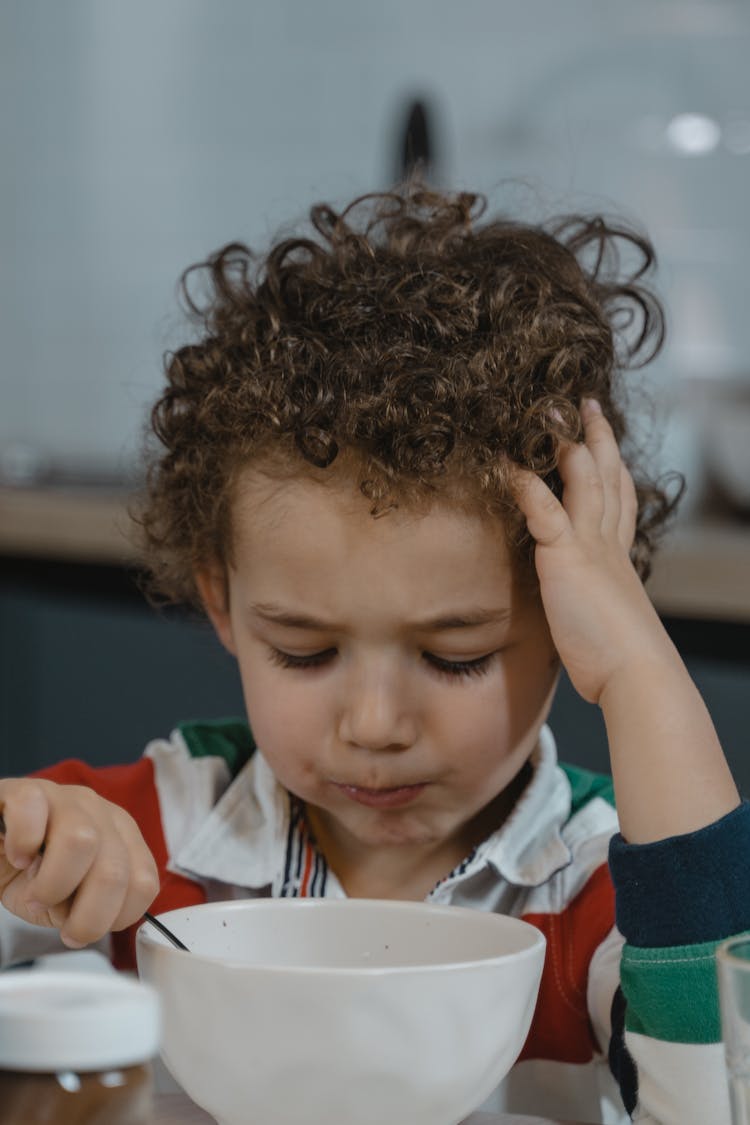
[31,757,206,969]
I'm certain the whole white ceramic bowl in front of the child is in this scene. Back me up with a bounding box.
[137,899,545,1125]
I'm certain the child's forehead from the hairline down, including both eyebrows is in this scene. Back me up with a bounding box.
[222,468,546,629]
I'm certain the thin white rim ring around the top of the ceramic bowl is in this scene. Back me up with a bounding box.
[136,898,546,977]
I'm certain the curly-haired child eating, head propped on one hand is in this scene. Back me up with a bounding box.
[0,186,750,1125]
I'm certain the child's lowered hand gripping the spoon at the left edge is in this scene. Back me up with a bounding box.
[0,777,159,948]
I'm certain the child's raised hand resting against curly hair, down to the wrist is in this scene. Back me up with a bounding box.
[517,402,675,703]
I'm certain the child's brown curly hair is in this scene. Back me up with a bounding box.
[136,183,676,603]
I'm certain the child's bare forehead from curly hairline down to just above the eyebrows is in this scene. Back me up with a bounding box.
[226,456,539,596]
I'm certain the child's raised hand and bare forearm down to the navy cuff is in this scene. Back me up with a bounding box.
[517,403,739,844]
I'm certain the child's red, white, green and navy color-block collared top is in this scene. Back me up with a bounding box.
[5,720,750,1125]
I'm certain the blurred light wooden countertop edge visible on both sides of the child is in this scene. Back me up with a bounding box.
[0,487,750,623]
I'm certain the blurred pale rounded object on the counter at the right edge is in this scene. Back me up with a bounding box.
[704,379,750,519]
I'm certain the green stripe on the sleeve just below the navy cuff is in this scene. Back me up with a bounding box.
[620,942,722,1043]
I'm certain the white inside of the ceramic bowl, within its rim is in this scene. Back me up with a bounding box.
[138,899,543,970]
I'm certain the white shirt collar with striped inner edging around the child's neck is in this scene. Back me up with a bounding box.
[170,727,571,898]
